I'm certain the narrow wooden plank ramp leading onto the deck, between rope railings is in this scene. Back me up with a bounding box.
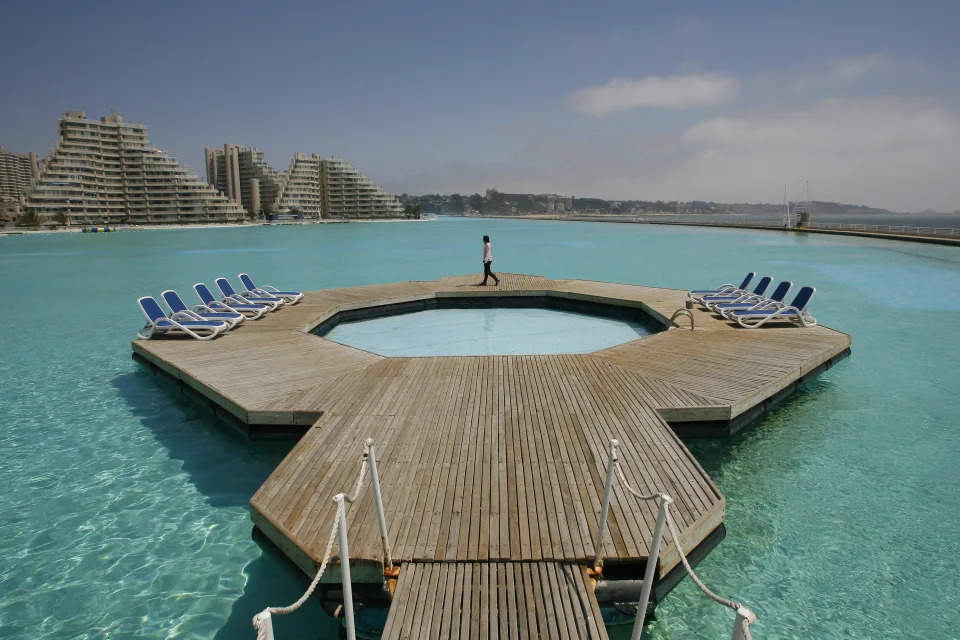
[382,562,607,640]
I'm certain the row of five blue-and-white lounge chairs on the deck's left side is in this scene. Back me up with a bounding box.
[137,273,303,340]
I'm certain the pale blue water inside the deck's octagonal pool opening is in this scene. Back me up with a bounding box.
[326,308,650,357]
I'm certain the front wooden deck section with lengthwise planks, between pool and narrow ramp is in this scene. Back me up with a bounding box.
[251,355,724,573]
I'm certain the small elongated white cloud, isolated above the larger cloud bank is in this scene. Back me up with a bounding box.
[570,73,740,118]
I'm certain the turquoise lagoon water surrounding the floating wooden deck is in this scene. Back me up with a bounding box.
[0,220,960,640]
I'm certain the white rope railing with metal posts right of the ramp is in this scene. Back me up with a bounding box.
[594,440,757,640]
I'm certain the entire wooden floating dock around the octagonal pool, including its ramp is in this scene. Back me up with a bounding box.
[133,274,850,638]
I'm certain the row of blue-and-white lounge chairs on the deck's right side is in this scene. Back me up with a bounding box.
[688,271,817,329]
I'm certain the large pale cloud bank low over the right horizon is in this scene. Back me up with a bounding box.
[661,98,960,211]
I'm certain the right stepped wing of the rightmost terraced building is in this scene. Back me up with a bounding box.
[323,158,403,218]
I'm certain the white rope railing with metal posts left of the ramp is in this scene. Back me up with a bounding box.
[253,438,393,640]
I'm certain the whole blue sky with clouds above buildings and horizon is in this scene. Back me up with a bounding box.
[0,0,960,212]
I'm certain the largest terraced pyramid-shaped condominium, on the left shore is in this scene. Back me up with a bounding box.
[26,111,245,224]
